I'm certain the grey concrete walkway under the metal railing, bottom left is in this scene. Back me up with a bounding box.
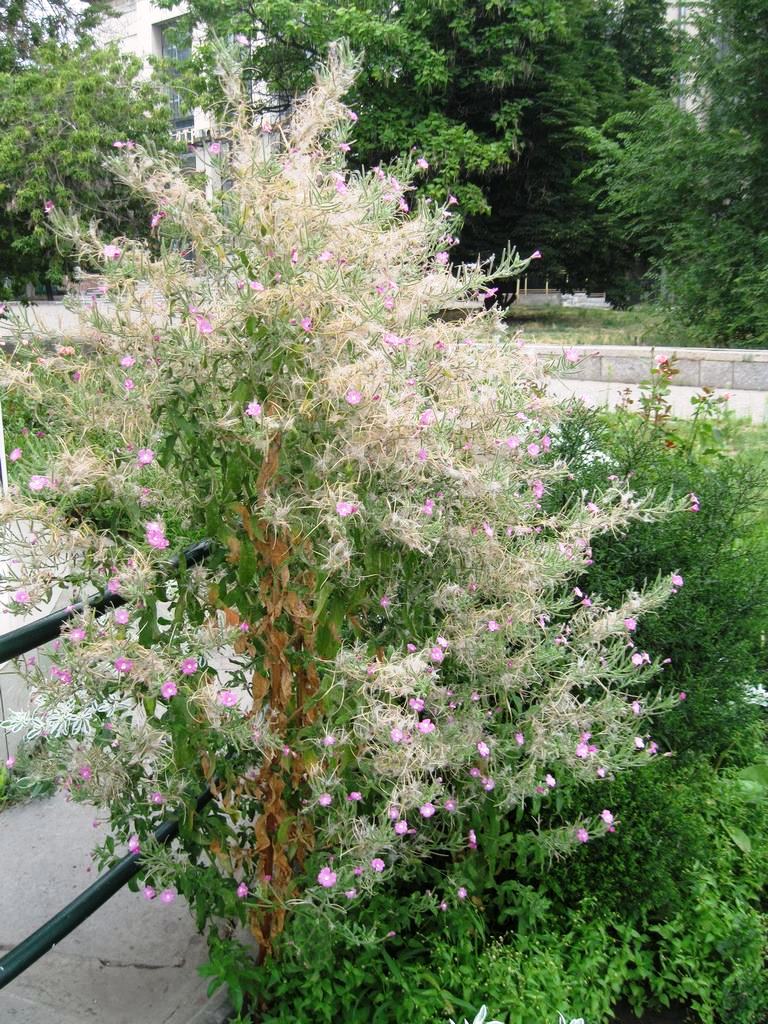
[0,797,227,1024]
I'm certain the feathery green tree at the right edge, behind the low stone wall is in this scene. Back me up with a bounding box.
[591,0,768,346]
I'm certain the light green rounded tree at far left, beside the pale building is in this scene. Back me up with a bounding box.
[0,42,176,292]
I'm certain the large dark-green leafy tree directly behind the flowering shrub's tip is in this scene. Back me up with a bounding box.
[162,0,672,288]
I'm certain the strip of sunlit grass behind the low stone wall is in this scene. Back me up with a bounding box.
[505,305,690,347]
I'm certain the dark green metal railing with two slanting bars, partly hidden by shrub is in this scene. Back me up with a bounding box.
[0,541,213,988]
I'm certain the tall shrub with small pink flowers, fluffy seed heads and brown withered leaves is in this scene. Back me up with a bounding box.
[3,46,683,983]
